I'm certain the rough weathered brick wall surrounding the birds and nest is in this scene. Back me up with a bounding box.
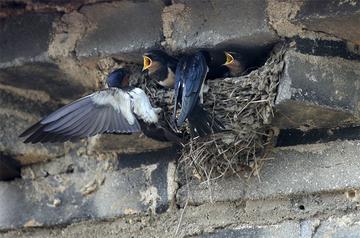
[0,0,360,237]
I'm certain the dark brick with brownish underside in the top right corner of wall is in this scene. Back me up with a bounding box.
[293,0,360,44]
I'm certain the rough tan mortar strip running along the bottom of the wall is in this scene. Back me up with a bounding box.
[0,188,359,238]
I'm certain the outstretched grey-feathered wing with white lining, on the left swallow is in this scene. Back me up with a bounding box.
[20,88,141,143]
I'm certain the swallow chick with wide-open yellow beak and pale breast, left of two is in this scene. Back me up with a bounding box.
[143,50,178,88]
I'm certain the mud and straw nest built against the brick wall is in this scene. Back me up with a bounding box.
[145,44,286,179]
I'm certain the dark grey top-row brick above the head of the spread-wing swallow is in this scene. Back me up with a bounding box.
[76,0,163,61]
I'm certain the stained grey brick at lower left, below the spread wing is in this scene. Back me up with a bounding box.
[0,151,176,229]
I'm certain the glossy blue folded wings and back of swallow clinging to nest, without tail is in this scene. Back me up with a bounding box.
[175,52,208,126]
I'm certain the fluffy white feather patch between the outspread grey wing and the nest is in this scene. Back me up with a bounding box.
[129,88,158,123]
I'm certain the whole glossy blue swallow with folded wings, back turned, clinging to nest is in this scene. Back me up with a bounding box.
[173,51,224,136]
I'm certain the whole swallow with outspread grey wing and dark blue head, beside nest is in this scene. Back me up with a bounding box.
[20,69,180,143]
